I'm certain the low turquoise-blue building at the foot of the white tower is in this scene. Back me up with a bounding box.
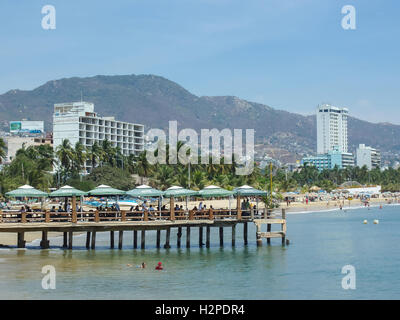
[301,147,354,171]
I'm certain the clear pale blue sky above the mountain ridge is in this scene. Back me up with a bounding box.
[0,0,400,124]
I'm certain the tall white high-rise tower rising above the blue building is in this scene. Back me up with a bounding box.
[317,104,349,154]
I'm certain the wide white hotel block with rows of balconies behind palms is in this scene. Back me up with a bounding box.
[53,101,144,172]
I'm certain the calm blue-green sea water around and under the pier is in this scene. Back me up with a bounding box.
[0,206,400,299]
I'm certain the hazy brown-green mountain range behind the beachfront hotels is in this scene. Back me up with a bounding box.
[0,74,400,161]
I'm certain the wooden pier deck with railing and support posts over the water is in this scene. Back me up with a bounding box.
[0,209,286,249]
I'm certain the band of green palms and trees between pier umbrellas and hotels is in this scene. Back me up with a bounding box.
[0,139,400,196]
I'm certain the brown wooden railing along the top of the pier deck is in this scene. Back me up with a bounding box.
[0,208,274,223]
